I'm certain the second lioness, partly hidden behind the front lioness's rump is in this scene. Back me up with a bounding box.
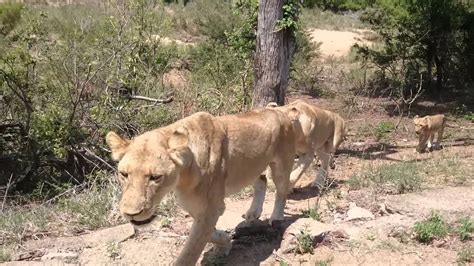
[267,100,345,188]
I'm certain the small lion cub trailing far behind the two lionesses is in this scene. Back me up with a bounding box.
[413,114,446,153]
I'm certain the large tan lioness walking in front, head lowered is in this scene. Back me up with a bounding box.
[106,109,295,265]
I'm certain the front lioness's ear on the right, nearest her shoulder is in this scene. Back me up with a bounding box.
[168,128,193,168]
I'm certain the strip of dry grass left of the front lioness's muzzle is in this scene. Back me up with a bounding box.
[0,179,123,245]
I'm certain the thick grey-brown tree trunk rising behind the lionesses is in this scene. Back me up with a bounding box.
[252,0,294,108]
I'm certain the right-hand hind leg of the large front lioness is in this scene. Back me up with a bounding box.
[269,159,292,225]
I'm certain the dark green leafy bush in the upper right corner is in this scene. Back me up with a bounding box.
[359,0,474,99]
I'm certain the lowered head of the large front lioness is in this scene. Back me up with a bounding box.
[106,128,192,224]
